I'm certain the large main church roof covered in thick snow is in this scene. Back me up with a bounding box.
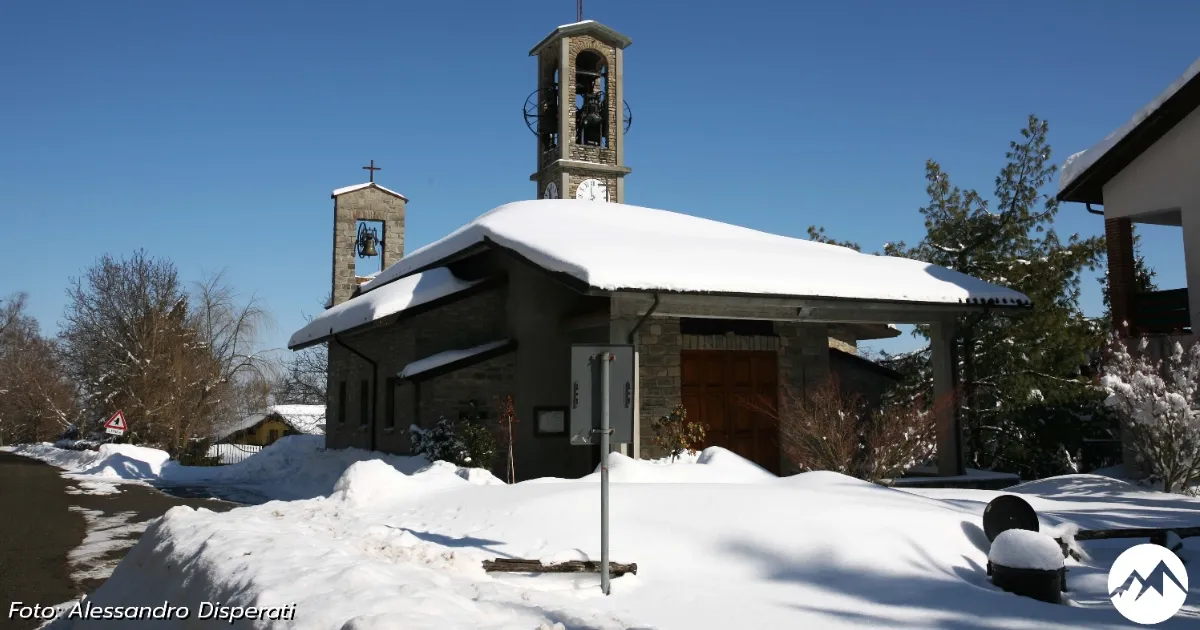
[361,199,1028,305]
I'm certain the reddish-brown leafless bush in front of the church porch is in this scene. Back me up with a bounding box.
[755,378,936,481]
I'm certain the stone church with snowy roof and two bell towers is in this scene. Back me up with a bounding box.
[288,20,1030,479]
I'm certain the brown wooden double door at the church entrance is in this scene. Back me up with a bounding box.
[682,350,779,474]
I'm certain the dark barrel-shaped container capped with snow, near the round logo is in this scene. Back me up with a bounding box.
[988,529,1067,604]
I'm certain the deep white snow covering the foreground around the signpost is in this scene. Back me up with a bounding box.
[37,449,1200,630]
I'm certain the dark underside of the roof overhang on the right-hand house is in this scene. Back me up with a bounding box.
[1056,64,1200,204]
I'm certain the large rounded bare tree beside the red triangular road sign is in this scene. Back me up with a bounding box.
[60,251,266,456]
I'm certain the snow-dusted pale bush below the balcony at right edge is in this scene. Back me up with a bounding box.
[1100,338,1200,492]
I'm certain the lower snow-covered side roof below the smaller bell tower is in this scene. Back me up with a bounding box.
[288,266,478,349]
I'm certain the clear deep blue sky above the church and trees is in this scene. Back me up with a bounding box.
[0,0,1200,348]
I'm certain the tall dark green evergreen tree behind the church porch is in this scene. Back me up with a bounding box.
[820,116,1105,478]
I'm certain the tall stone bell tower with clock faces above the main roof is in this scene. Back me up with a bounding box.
[524,19,632,203]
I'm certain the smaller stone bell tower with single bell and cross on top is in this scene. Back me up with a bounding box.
[329,160,408,306]
